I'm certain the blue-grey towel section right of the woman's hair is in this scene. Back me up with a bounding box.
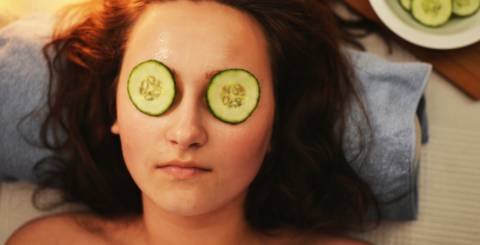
[345,50,431,220]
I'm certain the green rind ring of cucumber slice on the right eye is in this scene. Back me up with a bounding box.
[205,68,262,125]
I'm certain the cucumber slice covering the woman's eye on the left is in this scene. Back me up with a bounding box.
[127,60,175,116]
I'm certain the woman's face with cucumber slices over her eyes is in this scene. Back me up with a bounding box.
[112,1,275,215]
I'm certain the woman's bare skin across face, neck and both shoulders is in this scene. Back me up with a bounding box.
[7,1,370,245]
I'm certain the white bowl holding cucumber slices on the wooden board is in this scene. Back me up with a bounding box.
[369,0,480,49]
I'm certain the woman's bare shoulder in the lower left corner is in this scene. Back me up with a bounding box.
[6,212,107,245]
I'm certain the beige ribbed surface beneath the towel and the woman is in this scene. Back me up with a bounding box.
[0,0,480,245]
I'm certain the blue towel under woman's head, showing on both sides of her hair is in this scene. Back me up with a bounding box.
[0,14,430,219]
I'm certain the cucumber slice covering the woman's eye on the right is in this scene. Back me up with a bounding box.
[205,69,260,124]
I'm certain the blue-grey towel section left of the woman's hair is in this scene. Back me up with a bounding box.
[0,14,53,181]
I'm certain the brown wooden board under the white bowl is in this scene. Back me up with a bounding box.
[346,0,480,100]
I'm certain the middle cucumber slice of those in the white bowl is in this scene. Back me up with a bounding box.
[411,0,452,27]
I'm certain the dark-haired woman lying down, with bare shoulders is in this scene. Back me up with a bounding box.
[7,0,376,244]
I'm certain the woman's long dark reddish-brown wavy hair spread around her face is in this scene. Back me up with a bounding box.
[35,0,379,237]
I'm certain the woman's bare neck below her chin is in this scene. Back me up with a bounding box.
[137,191,258,245]
